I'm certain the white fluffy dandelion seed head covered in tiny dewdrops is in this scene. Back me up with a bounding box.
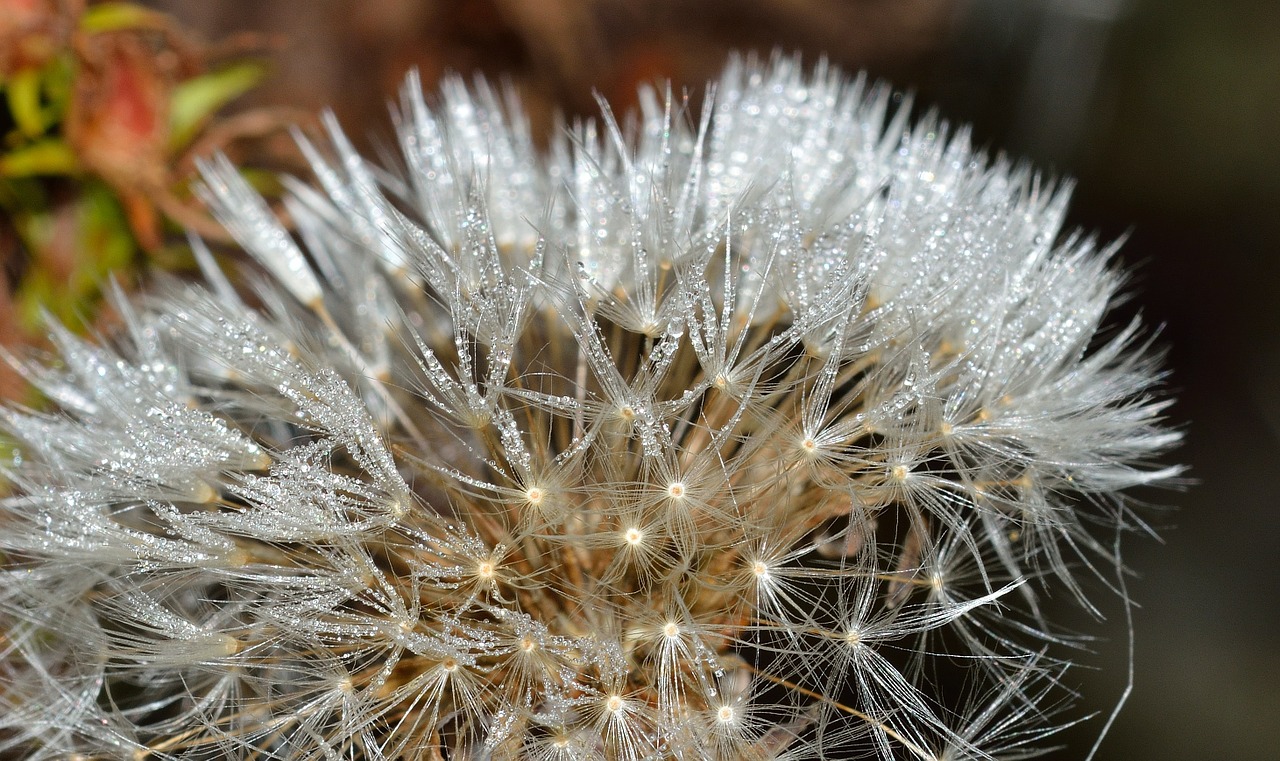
[0,50,1179,761]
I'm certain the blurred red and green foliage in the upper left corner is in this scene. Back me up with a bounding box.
[0,0,308,398]
